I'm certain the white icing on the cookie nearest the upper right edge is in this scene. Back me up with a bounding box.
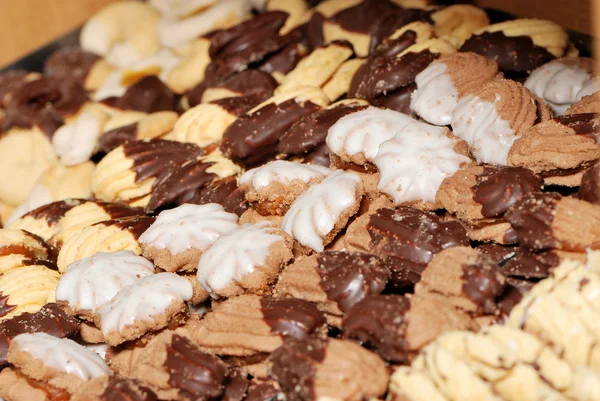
[524,60,591,114]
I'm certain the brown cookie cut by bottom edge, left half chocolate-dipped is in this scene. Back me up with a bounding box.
[268,338,389,401]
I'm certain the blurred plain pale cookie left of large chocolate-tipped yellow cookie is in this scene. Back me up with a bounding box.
[6,161,96,227]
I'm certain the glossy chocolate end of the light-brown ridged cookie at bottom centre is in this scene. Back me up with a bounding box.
[260,298,325,340]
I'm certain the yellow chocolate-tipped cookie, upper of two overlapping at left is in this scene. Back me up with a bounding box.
[50,201,143,247]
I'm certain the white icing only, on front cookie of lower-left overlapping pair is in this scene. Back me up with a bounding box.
[98,273,193,335]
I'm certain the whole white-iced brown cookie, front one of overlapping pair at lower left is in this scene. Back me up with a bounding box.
[94,273,193,346]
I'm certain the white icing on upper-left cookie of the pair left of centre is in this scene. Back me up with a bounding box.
[139,203,238,255]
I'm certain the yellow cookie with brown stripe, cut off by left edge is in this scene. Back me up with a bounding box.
[0,228,54,273]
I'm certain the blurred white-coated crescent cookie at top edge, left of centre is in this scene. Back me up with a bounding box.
[157,0,251,48]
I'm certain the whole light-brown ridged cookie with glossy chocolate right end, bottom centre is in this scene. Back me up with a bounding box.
[192,295,325,357]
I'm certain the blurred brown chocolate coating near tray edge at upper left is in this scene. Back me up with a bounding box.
[44,47,101,86]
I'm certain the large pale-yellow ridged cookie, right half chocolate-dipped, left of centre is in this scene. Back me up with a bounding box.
[92,139,203,206]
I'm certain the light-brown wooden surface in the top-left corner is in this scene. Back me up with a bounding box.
[0,0,118,66]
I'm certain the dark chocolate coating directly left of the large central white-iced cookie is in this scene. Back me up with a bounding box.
[277,104,367,155]
